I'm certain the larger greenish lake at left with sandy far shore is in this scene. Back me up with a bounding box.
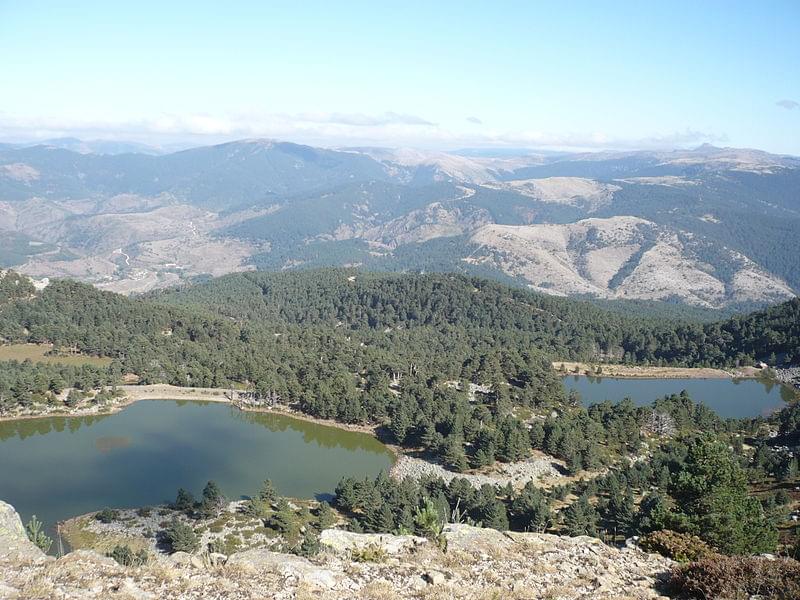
[0,400,393,531]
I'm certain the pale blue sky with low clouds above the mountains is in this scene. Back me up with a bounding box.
[0,0,800,155]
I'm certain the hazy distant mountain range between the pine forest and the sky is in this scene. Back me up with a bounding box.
[0,139,800,310]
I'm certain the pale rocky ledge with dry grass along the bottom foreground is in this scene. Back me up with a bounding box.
[0,501,672,600]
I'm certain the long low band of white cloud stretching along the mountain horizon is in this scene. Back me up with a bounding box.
[0,111,727,150]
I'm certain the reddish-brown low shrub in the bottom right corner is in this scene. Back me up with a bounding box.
[668,555,800,600]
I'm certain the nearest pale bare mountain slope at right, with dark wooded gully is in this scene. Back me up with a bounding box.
[464,216,794,308]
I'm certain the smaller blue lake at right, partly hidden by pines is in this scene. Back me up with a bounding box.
[564,375,793,418]
